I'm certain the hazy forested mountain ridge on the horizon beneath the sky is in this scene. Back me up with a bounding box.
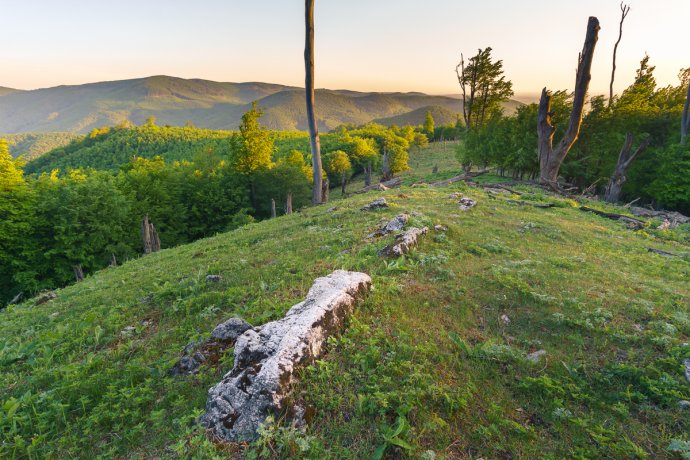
[0,76,490,134]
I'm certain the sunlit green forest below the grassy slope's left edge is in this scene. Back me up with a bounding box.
[0,105,426,305]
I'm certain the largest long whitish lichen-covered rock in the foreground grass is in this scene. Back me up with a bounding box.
[199,270,371,442]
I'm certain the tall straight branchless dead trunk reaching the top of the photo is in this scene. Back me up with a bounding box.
[304,0,322,204]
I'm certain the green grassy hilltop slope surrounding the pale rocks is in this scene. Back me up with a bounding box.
[0,142,690,459]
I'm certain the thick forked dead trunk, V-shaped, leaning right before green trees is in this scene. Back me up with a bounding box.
[537,16,599,188]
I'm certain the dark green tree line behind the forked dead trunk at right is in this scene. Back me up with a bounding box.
[456,17,690,212]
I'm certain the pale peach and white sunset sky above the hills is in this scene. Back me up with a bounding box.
[0,0,690,94]
